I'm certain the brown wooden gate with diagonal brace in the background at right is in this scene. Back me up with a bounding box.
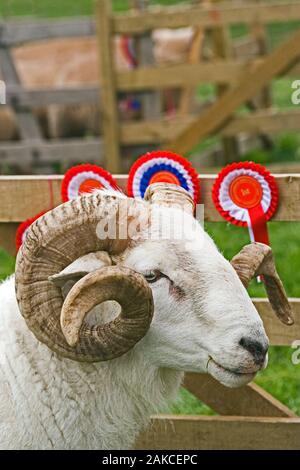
[97,0,300,172]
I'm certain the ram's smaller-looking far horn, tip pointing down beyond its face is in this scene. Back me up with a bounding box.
[231,243,294,325]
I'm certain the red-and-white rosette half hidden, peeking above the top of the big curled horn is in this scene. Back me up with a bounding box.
[61,163,120,202]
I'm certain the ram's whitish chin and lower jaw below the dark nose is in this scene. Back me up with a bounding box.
[206,356,258,387]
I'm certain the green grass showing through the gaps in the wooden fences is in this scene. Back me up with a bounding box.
[0,0,300,415]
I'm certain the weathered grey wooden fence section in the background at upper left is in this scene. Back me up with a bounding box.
[0,19,103,173]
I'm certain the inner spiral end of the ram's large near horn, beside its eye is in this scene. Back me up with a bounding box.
[60,266,153,361]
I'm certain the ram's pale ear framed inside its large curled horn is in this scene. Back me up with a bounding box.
[48,251,112,299]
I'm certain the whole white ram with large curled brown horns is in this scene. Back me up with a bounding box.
[0,184,291,449]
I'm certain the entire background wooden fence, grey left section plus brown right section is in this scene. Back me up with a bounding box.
[0,0,300,173]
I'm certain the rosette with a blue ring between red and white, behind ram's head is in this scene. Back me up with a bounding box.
[127,150,199,203]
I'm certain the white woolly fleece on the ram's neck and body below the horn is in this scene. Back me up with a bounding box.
[0,277,183,450]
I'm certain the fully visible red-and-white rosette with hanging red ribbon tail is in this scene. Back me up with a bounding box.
[212,162,278,245]
